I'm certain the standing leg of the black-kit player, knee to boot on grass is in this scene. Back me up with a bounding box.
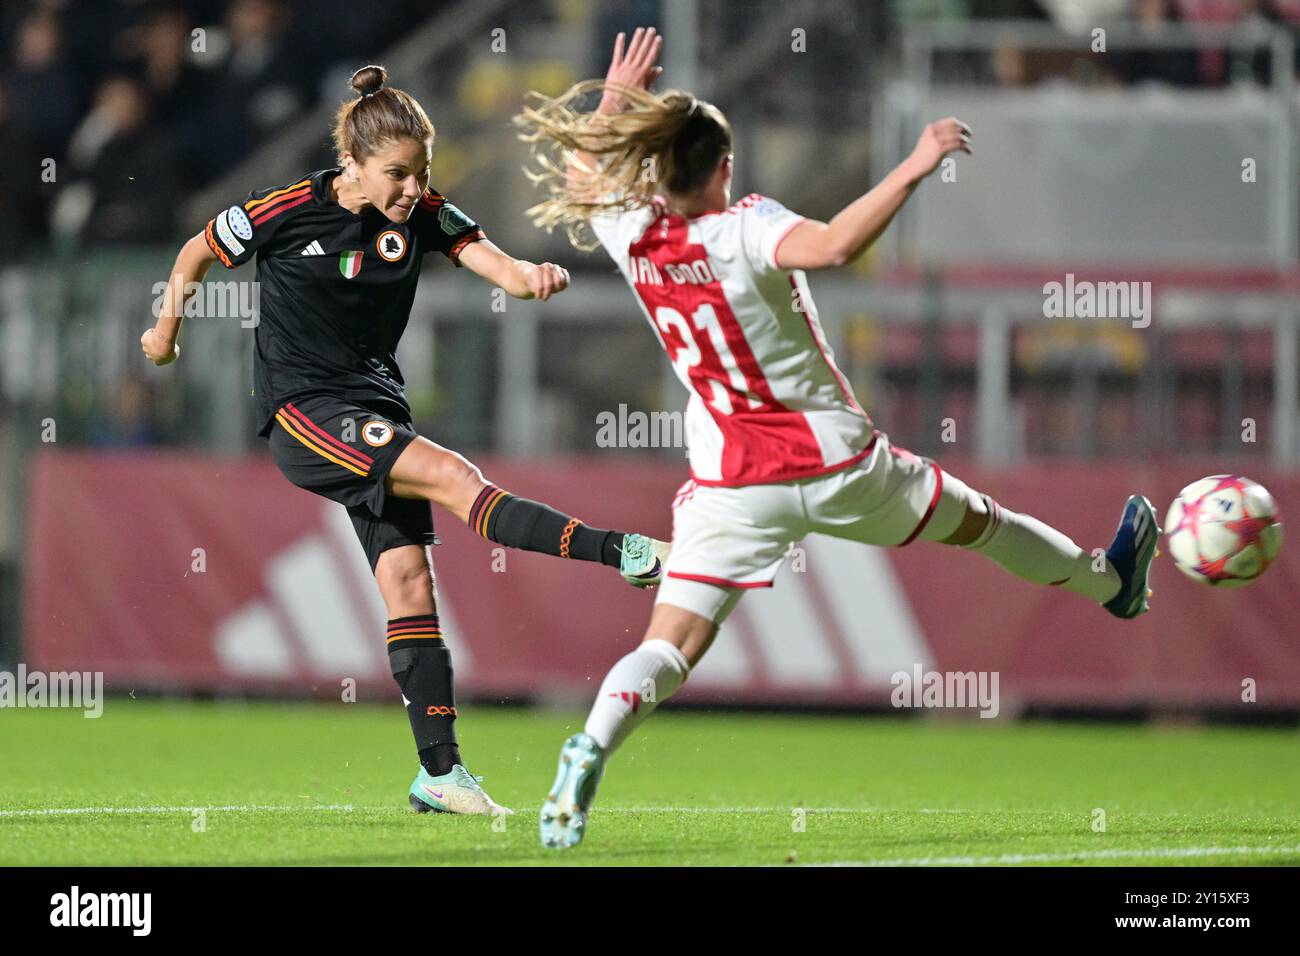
[374,545,511,813]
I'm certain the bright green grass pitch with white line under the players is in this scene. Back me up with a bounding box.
[0,698,1300,866]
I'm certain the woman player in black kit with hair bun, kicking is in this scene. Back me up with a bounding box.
[140,66,667,813]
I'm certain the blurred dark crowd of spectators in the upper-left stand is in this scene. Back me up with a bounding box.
[0,0,439,261]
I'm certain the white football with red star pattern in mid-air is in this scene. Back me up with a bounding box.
[1165,475,1282,588]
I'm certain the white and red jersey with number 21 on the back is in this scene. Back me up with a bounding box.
[592,194,874,485]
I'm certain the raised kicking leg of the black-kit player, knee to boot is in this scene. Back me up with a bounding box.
[385,437,668,588]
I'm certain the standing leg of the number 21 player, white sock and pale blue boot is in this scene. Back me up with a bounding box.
[541,590,741,848]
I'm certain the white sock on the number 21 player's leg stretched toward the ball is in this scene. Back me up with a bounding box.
[966,496,1119,604]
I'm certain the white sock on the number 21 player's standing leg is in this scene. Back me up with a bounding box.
[586,640,690,754]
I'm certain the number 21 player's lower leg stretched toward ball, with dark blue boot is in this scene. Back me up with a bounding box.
[920,472,1160,618]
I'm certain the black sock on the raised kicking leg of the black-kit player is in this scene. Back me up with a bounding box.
[469,485,625,567]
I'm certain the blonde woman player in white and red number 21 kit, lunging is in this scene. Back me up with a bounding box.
[517,29,1160,847]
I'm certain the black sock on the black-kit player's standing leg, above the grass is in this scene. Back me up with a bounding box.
[389,614,460,777]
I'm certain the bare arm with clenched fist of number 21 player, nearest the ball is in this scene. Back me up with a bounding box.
[776,116,974,269]
